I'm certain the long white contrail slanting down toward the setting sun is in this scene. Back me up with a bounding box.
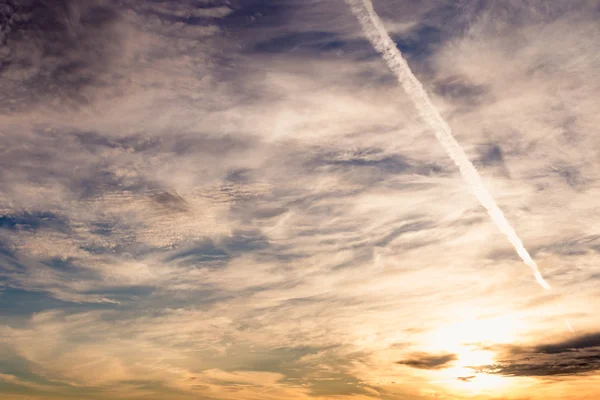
[345,0,551,290]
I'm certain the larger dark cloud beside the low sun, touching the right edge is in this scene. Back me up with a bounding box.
[475,333,600,376]
